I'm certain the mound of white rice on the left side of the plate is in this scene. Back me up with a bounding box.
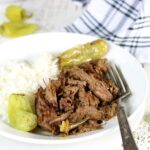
[0,54,58,121]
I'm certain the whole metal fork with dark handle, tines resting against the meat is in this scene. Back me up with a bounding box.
[108,64,138,150]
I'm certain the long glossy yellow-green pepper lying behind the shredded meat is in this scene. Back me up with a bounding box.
[59,39,108,68]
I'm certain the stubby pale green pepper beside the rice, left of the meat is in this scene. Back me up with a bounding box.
[8,94,37,131]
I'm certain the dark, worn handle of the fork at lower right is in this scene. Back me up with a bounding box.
[117,105,138,150]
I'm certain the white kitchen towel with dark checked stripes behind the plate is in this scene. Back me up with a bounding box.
[65,0,150,63]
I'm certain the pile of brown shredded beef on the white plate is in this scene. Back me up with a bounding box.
[36,59,119,135]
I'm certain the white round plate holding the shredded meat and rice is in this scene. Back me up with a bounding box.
[0,33,148,146]
